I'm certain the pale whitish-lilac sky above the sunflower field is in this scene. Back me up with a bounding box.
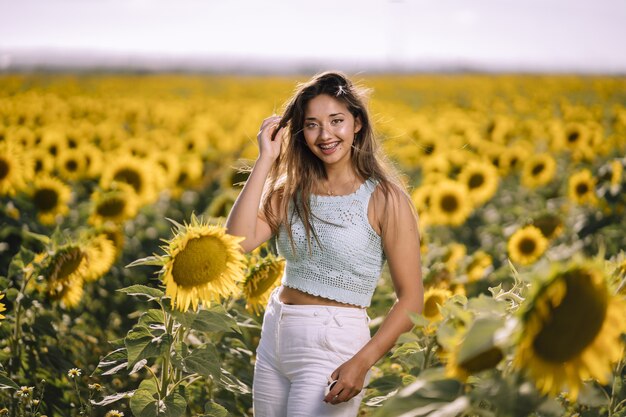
[0,0,626,73]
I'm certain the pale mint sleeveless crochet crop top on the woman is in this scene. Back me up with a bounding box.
[276,179,385,307]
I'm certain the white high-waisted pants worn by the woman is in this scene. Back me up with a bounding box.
[252,287,371,417]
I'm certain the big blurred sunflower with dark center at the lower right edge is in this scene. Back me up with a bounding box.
[513,260,626,399]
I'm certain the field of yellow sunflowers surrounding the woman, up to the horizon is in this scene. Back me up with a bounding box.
[0,74,626,417]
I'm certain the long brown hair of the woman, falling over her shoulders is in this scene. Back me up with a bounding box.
[262,71,408,248]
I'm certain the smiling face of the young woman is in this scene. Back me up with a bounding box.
[303,94,361,165]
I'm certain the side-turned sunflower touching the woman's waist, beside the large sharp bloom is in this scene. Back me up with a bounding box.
[242,254,285,315]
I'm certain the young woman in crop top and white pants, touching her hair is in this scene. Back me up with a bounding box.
[226,72,423,417]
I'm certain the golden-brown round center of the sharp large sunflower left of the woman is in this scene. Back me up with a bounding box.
[172,236,228,287]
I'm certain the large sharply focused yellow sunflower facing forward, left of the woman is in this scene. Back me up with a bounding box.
[162,216,245,311]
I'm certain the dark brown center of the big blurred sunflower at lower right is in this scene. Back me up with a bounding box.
[533,269,608,363]
